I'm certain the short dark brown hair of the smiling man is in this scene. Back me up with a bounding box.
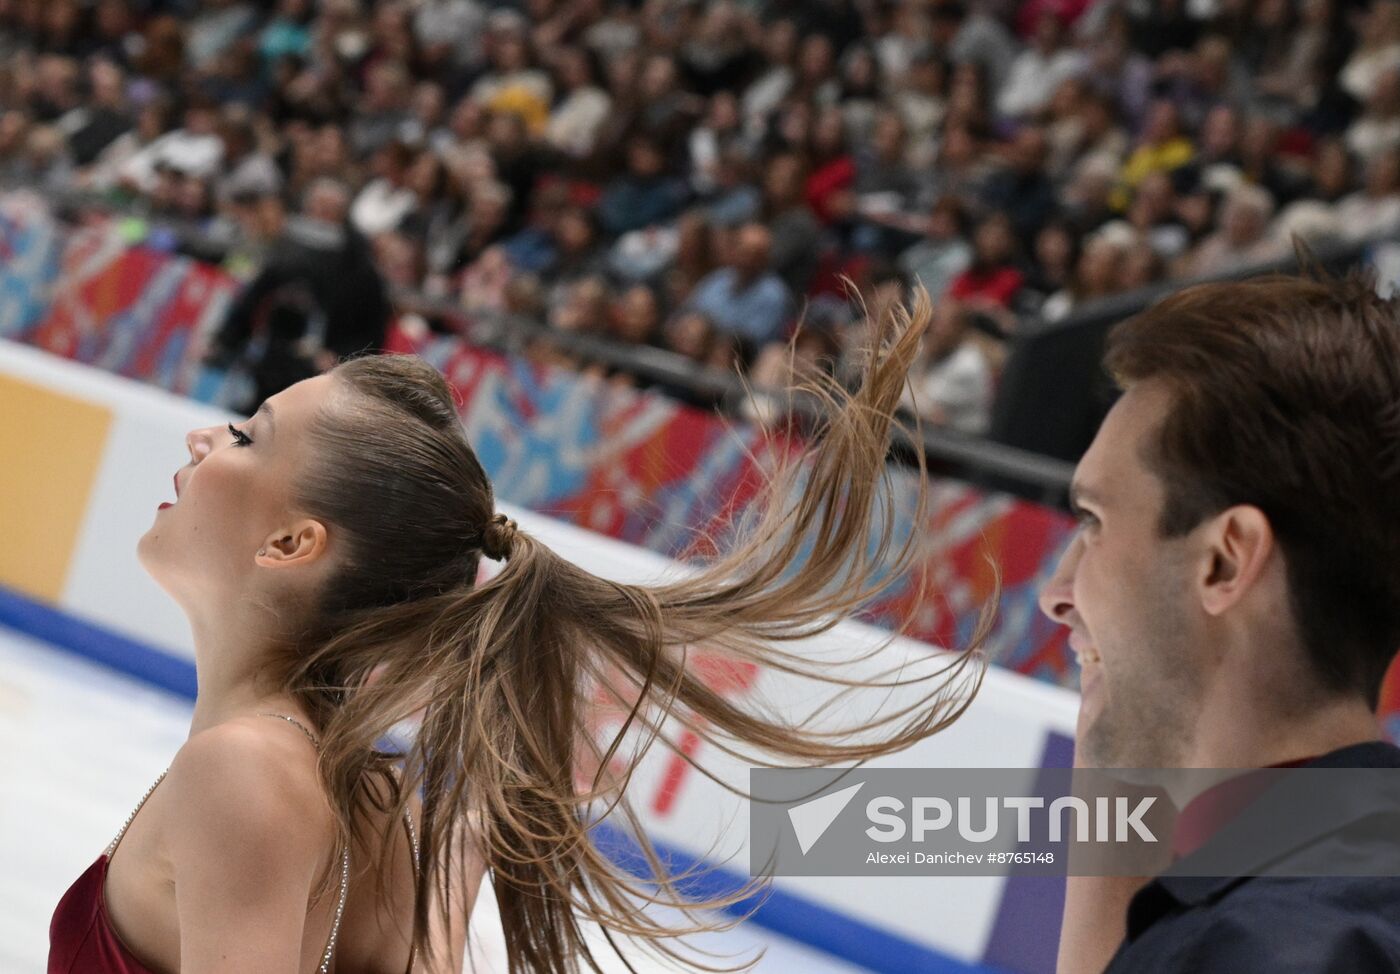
[1105,263,1400,708]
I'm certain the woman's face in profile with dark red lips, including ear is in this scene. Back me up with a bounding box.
[137,375,335,613]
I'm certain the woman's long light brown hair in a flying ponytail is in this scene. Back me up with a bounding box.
[273,290,1000,973]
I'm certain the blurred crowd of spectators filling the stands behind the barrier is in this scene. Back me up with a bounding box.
[0,0,1400,434]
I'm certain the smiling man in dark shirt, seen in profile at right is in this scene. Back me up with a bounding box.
[1040,263,1400,974]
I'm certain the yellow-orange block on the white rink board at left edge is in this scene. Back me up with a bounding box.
[0,375,112,603]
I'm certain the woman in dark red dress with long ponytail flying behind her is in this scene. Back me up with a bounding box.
[49,292,995,974]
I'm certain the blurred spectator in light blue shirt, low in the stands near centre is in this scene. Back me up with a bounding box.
[689,223,794,346]
